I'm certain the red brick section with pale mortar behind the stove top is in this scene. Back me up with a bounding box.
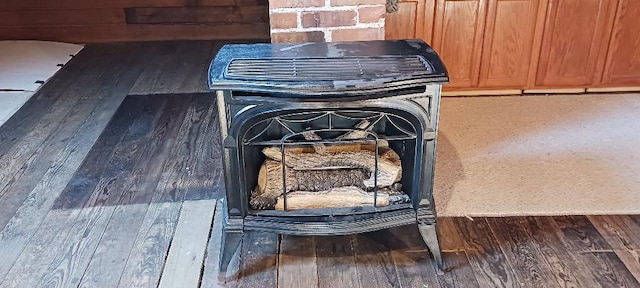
[269,0,386,43]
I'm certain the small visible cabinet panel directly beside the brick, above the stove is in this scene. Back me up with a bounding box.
[384,2,420,40]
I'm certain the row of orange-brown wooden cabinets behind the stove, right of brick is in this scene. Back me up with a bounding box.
[385,0,640,90]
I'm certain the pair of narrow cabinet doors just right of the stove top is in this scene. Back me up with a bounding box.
[432,0,539,88]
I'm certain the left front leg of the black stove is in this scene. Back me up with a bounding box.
[218,231,242,283]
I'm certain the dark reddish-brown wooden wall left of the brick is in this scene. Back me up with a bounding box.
[0,0,269,43]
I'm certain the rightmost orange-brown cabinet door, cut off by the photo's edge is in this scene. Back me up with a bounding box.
[602,0,640,86]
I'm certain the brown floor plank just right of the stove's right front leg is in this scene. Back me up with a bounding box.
[436,217,480,288]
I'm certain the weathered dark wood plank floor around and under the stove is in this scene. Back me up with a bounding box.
[0,41,640,288]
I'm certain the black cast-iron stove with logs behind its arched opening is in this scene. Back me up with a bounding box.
[209,40,448,274]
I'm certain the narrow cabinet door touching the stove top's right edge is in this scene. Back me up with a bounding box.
[432,0,486,88]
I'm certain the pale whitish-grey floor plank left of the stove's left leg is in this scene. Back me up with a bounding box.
[158,199,217,288]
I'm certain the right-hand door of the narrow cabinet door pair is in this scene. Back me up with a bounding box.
[478,0,539,88]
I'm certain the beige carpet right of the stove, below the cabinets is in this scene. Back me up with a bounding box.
[434,94,640,216]
